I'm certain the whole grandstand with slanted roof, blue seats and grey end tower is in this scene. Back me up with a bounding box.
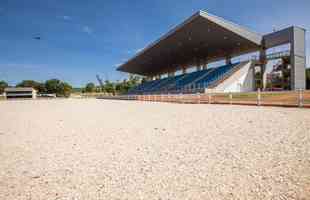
[117,11,306,94]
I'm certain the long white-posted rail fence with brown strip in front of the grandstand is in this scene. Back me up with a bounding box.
[99,90,310,108]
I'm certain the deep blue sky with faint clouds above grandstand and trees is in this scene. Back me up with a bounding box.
[0,0,310,86]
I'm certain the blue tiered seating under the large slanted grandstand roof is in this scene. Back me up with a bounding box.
[129,63,239,94]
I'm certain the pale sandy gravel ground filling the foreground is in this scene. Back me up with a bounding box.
[0,99,310,200]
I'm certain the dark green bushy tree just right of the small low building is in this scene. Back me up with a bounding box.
[45,79,72,97]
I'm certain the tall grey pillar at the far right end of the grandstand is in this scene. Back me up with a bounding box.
[290,27,306,90]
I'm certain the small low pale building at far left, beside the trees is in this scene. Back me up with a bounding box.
[4,87,37,99]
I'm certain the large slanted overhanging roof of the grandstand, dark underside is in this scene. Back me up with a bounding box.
[117,11,263,76]
